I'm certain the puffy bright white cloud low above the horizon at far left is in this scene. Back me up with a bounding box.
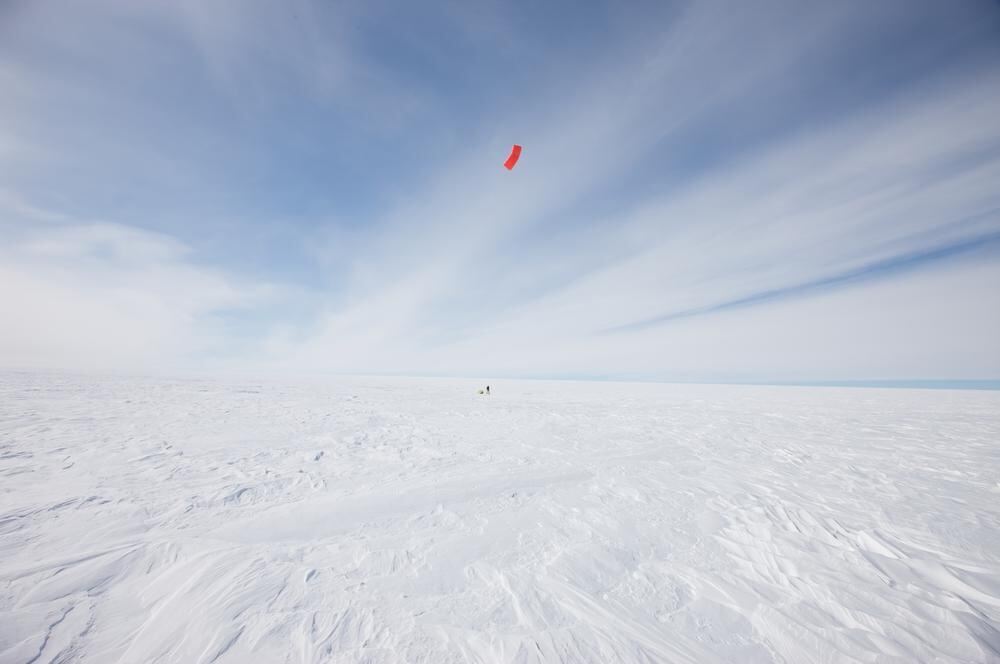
[0,215,275,371]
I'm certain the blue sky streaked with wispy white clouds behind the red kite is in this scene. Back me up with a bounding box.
[0,0,1000,382]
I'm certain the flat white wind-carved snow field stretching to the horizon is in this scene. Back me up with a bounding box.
[0,374,1000,664]
